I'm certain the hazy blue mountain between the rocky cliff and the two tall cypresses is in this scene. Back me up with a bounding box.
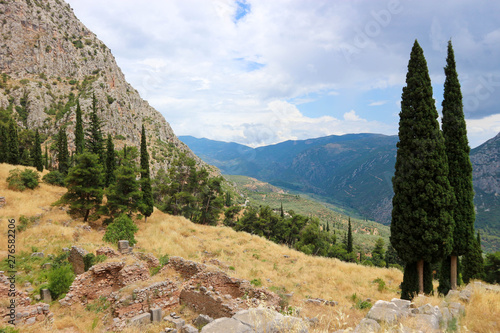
[179,134,398,220]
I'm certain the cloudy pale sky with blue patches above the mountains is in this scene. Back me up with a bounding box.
[66,0,500,148]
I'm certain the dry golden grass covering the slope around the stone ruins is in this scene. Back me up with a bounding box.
[0,164,500,332]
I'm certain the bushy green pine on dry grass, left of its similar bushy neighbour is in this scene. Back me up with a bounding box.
[57,152,104,222]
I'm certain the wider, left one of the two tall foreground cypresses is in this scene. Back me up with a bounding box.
[391,40,454,293]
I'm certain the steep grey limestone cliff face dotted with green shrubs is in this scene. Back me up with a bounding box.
[0,0,208,170]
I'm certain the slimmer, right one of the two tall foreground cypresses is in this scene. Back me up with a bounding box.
[442,41,475,289]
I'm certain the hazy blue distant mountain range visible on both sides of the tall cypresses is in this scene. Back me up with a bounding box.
[179,133,500,250]
